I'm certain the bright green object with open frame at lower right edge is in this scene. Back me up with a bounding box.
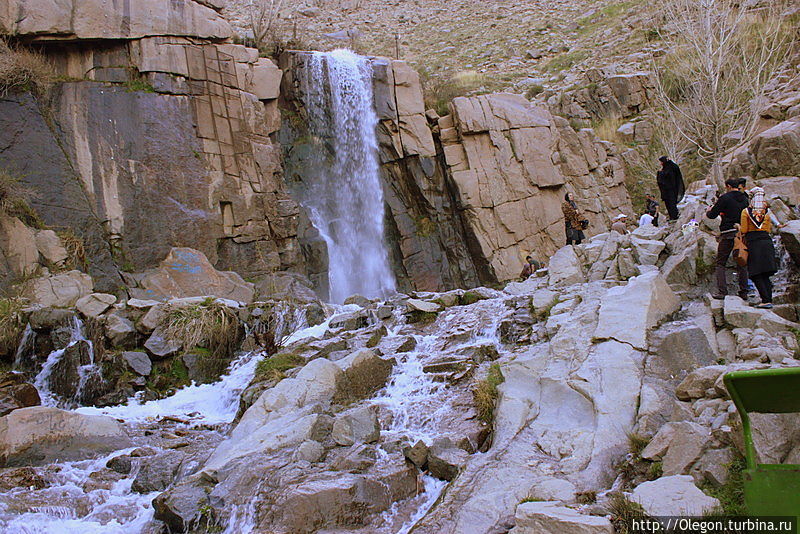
[723,367,800,516]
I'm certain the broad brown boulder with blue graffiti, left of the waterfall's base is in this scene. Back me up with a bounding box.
[137,248,255,304]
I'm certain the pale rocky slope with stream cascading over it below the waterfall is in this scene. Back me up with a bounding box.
[0,184,800,533]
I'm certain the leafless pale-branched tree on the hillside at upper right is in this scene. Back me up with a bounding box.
[653,0,794,184]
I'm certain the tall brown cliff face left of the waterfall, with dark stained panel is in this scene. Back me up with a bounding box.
[0,9,301,290]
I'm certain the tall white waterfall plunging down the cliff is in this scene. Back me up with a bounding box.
[300,50,395,303]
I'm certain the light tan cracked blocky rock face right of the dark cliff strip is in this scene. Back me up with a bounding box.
[439,94,631,280]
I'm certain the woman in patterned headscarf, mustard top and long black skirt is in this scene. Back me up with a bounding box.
[739,187,778,308]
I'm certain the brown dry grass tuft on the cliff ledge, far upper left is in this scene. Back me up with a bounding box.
[0,38,55,97]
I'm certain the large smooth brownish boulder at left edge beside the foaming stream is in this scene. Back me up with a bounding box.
[0,406,133,467]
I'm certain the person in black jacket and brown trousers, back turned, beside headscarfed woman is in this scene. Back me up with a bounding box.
[706,178,750,300]
